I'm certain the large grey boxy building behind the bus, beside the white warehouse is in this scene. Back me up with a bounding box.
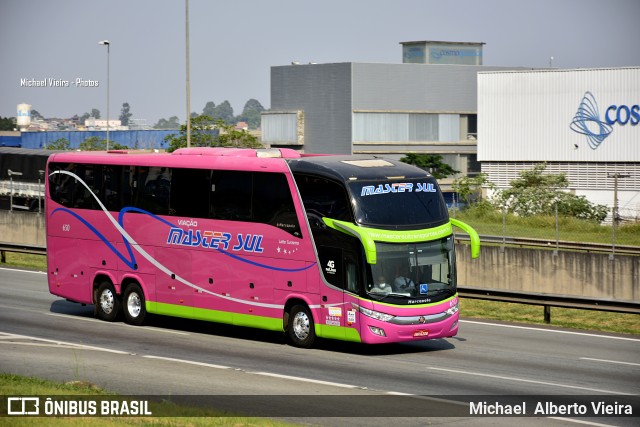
[262,42,524,181]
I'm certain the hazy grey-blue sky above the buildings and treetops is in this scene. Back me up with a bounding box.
[0,0,640,125]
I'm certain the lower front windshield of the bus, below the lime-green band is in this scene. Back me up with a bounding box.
[367,236,456,304]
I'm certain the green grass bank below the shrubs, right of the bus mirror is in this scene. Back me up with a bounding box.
[450,207,640,246]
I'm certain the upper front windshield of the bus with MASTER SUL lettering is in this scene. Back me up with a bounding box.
[349,177,449,228]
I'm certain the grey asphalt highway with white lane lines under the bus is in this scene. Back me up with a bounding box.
[0,268,640,425]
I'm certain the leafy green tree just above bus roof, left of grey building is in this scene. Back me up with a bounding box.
[164,115,262,152]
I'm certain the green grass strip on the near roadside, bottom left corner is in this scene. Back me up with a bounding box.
[0,374,295,427]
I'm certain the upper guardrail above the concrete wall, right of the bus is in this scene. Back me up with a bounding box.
[456,234,640,255]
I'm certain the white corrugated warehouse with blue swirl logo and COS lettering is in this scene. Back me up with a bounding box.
[478,67,640,220]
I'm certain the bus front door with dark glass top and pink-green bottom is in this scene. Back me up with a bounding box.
[318,246,362,339]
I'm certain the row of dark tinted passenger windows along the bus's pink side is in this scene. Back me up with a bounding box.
[49,163,302,237]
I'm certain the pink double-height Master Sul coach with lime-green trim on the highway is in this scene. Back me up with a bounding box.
[45,148,480,347]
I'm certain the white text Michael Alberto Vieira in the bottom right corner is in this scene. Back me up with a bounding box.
[469,401,633,417]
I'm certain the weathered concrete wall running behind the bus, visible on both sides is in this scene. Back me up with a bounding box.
[0,210,640,301]
